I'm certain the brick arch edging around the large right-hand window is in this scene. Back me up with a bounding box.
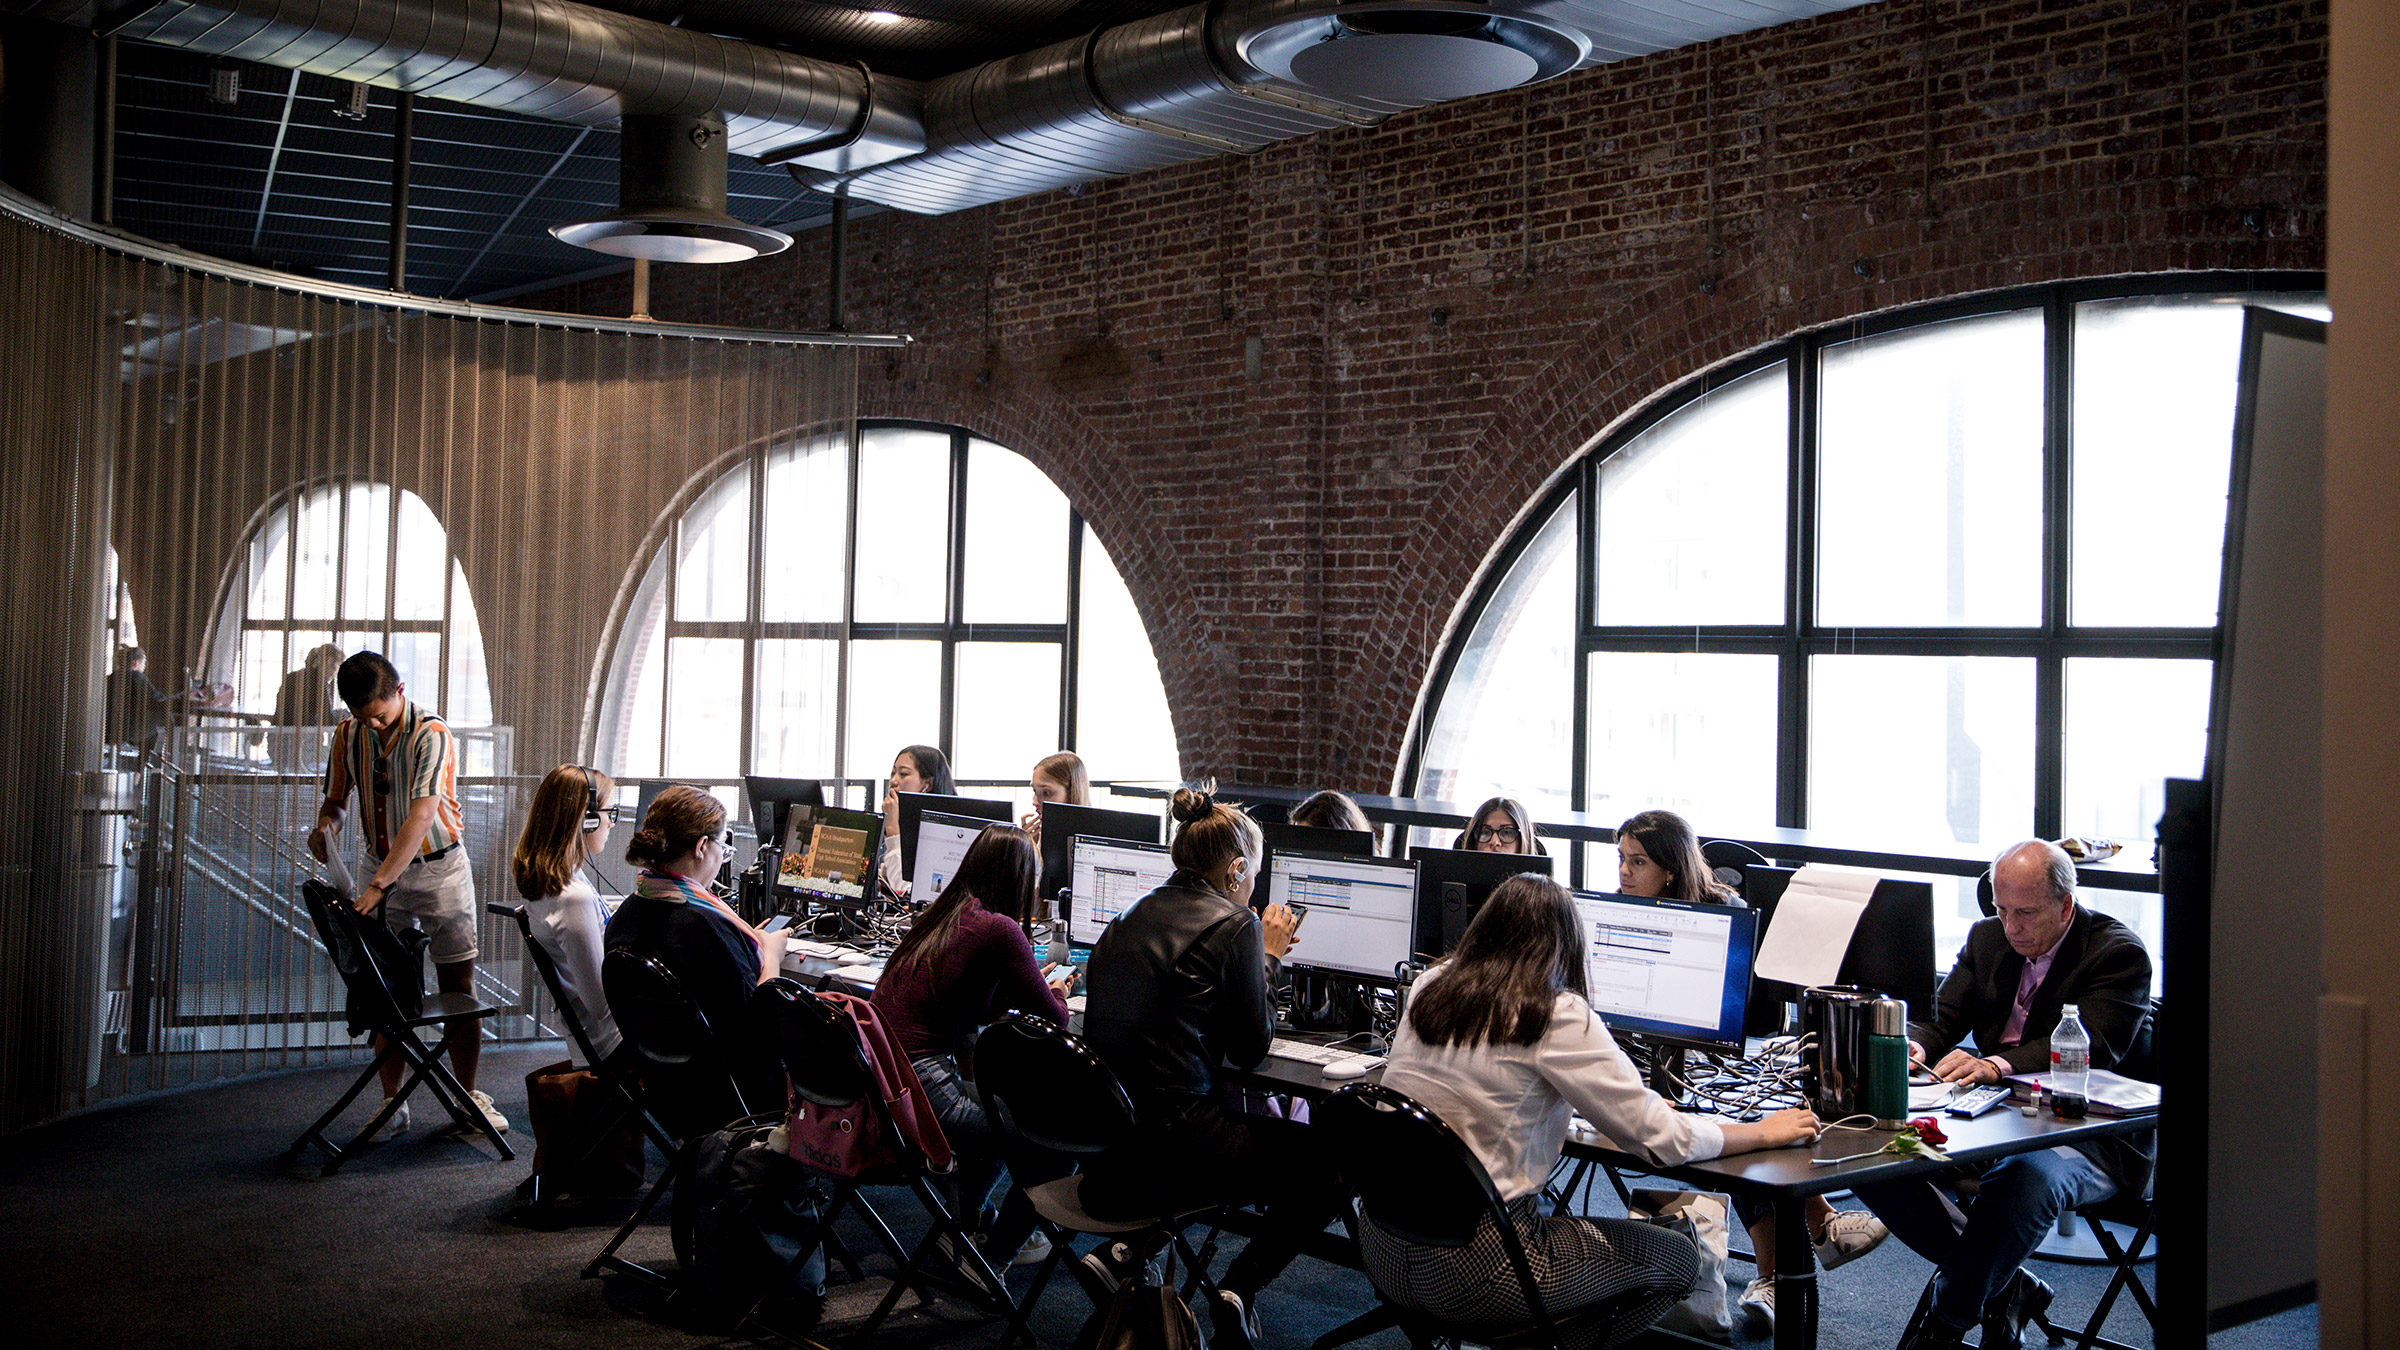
[1327,238,2321,790]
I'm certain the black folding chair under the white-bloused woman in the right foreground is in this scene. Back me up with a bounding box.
[1310,1083,1656,1350]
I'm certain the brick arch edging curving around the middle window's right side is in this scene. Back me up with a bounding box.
[859,353,1217,764]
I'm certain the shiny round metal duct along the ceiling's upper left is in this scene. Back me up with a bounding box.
[106,0,924,168]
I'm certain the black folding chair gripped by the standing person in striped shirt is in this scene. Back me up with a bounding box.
[290,882,516,1177]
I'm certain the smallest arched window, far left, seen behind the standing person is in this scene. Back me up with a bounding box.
[209,478,494,773]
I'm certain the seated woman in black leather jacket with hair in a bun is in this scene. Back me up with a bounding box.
[1082,788,1342,1350]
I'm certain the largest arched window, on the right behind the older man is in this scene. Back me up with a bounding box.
[1414,279,2323,954]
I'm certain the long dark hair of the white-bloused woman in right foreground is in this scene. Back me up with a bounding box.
[1409,872,1591,1047]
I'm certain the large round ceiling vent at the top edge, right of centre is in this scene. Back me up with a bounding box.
[1236,0,1591,103]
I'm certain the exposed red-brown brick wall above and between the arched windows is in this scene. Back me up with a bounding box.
[511,0,2326,790]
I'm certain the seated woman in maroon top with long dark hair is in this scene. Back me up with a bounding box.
[874,824,1075,1264]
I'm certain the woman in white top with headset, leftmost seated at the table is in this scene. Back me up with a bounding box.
[509,764,624,1059]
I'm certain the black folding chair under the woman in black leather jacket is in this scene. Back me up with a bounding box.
[974,1014,1224,1345]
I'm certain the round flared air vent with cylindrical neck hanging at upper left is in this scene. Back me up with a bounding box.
[550,113,792,262]
